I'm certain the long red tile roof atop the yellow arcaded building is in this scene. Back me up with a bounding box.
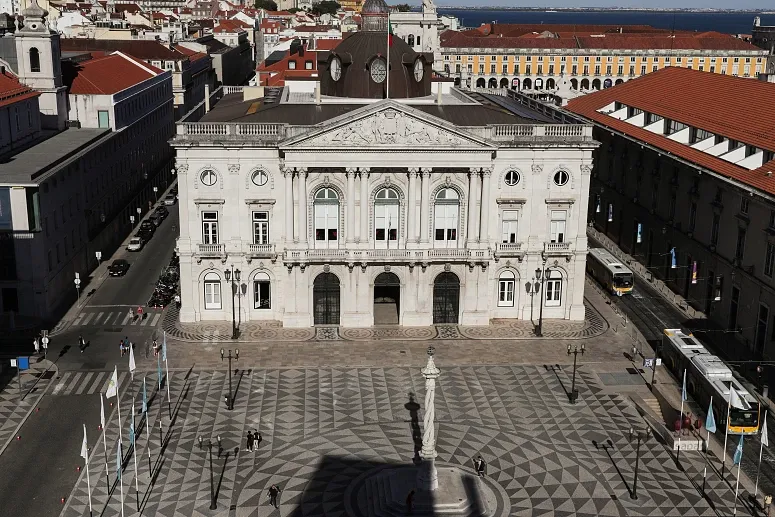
[441,24,761,51]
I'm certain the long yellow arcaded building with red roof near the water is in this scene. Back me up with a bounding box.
[440,23,769,96]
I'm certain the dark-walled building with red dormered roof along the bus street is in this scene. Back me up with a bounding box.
[568,68,775,358]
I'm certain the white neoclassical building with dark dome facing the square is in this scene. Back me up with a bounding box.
[173,0,597,327]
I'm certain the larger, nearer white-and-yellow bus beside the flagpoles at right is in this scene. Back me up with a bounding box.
[661,329,760,434]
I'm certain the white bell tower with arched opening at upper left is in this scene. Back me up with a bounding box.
[14,0,67,130]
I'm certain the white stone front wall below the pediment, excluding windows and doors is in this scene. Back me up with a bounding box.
[173,111,594,327]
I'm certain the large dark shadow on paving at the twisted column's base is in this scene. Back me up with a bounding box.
[282,455,488,517]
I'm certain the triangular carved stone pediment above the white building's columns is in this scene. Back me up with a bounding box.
[280,100,492,150]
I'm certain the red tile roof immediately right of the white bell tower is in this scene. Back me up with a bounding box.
[65,52,163,95]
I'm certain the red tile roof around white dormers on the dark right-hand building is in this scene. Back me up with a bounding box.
[567,67,775,194]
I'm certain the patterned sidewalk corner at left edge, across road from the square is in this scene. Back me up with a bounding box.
[0,356,57,454]
